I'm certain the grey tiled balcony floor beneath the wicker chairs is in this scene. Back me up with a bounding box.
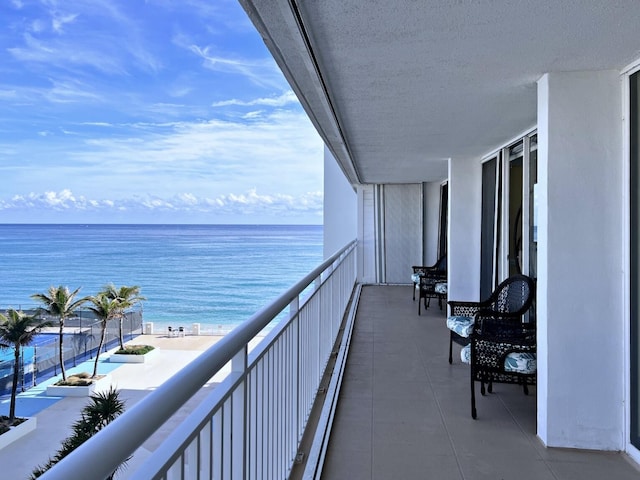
[322,286,640,480]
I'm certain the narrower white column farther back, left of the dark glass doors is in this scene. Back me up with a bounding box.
[447,158,482,301]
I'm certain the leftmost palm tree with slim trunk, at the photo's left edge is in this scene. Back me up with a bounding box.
[0,309,51,424]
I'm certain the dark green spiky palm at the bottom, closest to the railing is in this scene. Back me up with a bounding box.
[30,387,124,479]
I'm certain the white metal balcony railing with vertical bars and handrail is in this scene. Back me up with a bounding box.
[41,241,356,480]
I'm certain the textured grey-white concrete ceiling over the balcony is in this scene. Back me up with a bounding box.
[240,0,640,184]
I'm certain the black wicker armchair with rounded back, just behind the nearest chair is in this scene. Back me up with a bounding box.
[447,275,534,363]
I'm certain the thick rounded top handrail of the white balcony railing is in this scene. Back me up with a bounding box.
[40,240,356,480]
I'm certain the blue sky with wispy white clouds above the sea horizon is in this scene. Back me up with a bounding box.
[0,0,323,224]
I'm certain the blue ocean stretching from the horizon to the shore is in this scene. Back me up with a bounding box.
[0,224,322,333]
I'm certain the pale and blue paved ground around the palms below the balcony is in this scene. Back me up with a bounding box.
[0,335,242,479]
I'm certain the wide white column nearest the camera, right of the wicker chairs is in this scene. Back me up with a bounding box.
[537,71,626,450]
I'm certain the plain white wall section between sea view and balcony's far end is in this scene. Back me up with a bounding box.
[323,147,358,258]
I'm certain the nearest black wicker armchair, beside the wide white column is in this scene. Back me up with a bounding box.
[461,311,537,419]
